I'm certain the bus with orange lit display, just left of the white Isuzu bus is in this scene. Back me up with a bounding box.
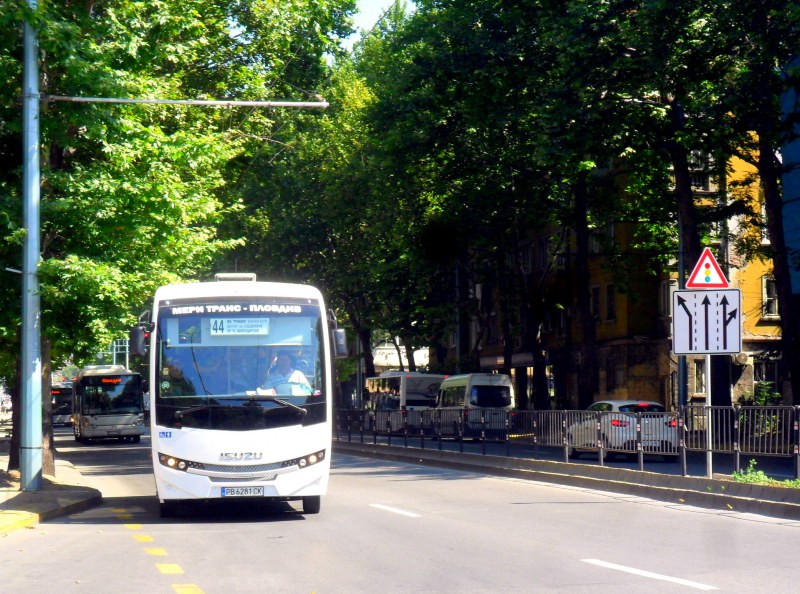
[72,365,144,442]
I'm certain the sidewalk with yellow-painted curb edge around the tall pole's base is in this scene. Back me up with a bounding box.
[0,414,103,535]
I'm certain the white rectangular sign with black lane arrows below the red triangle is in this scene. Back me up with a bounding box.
[672,289,742,355]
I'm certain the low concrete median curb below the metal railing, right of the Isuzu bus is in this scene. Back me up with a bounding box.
[333,441,800,520]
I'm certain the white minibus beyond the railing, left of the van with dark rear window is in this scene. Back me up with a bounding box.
[365,371,447,433]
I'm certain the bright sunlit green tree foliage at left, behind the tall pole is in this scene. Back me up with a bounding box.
[0,0,354,377]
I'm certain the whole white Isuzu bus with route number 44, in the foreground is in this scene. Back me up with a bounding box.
[131,274,346,517]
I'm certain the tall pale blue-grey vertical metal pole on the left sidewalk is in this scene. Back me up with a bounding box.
[20,0,42,491]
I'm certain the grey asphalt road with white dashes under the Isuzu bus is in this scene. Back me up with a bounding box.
[0,428,800,594]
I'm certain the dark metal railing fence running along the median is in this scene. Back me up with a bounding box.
[334,405,800,478]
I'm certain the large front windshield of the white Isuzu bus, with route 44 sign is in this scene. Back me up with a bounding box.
[154,298,327,431]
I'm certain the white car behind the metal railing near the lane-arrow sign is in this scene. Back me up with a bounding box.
[567,400,679,458]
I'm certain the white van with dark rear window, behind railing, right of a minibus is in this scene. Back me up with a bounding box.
[433,373,515,439]
